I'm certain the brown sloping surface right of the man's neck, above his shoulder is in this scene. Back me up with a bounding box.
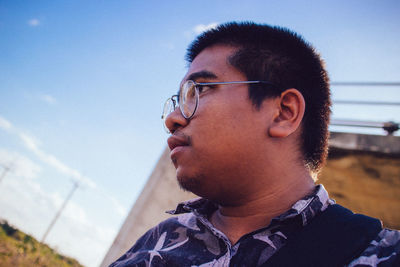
[318,150,400,229]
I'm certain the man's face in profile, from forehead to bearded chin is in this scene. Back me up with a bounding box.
[166,45,267,204]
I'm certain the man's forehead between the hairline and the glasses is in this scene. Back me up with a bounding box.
[182,45,244,82]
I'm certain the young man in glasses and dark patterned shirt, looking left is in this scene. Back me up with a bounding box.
[111,23,400,266]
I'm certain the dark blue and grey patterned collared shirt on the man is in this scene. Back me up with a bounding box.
[110,185,400,267]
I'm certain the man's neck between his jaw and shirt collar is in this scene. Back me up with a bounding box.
[210,174,315,244]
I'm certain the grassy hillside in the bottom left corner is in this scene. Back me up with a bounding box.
[0,221,82,267]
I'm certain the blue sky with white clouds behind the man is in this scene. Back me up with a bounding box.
[0,0,400,266]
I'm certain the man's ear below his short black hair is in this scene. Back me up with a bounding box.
[268,88,306,137]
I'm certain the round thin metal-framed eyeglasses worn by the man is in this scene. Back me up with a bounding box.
[161,80,272,133]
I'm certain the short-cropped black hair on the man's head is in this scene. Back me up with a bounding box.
[186,22,331,175]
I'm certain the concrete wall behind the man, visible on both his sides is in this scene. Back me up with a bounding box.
[101,133,400,266]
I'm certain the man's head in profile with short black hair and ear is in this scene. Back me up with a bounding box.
[165,23,330,203]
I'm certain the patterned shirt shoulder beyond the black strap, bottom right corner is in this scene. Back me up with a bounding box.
[348,229,400,267]
